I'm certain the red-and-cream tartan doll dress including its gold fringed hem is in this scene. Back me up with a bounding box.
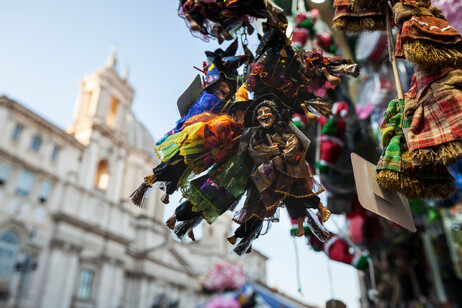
[405,69,462,165]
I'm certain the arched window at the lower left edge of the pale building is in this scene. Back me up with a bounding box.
[0,231,20,286]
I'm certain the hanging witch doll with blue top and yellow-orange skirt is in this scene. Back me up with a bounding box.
[130,69,238,206]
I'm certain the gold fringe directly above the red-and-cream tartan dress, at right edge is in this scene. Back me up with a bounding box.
[402,40,462,69]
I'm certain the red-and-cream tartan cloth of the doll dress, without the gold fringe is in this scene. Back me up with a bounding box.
[406,69,462,151]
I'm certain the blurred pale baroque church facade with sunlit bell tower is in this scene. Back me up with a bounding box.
[0,56,267,308]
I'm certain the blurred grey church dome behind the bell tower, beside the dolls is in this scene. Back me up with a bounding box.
[125,112,155,156]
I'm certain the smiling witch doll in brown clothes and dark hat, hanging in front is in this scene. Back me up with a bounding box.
[228,94,331,255]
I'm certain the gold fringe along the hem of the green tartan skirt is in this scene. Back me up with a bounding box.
[377,169,456,199]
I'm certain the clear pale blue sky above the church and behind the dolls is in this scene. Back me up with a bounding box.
[0,0,359,307]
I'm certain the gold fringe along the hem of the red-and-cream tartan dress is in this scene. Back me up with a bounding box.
[405,140,462,166]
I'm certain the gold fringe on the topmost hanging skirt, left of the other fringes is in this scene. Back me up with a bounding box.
[332,16,387,33]
